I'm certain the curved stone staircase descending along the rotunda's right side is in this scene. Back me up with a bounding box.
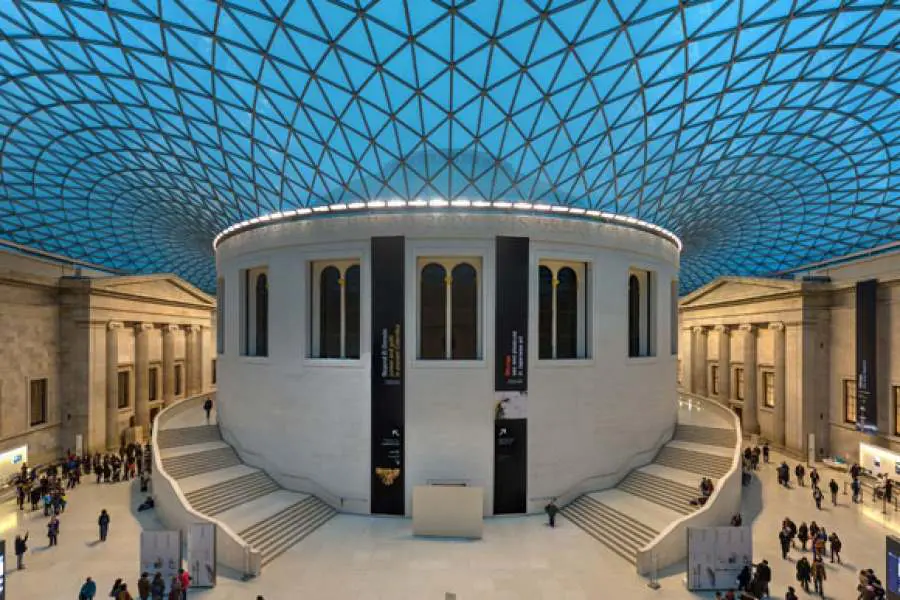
[562,424,737,563]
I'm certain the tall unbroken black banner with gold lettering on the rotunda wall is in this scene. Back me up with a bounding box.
[371,237,406,515]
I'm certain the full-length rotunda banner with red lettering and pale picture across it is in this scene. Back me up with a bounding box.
[494,237,529,514]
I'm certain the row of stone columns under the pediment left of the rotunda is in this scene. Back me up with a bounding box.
[106,321,203,448]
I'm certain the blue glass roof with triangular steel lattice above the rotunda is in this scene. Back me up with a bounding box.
[0,0,900,290]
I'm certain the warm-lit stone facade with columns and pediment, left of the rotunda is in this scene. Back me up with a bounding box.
[0,251,216,463]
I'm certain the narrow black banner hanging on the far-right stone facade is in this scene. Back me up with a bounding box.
[856,279,878,433]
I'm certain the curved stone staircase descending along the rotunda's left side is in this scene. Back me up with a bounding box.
[157,425,337,565]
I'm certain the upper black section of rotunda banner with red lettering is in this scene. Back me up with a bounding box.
[494,237,528,392]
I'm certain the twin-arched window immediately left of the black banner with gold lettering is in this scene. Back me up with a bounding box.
[309,259,362,359]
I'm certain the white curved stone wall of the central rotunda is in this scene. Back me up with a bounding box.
[216,211,679,514]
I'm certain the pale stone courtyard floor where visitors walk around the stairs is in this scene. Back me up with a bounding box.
[0,446,900,600]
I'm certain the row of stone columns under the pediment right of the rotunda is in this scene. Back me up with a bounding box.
[690,322,787,446]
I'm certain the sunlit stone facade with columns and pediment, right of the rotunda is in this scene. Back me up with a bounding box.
[679,253,900,460]
